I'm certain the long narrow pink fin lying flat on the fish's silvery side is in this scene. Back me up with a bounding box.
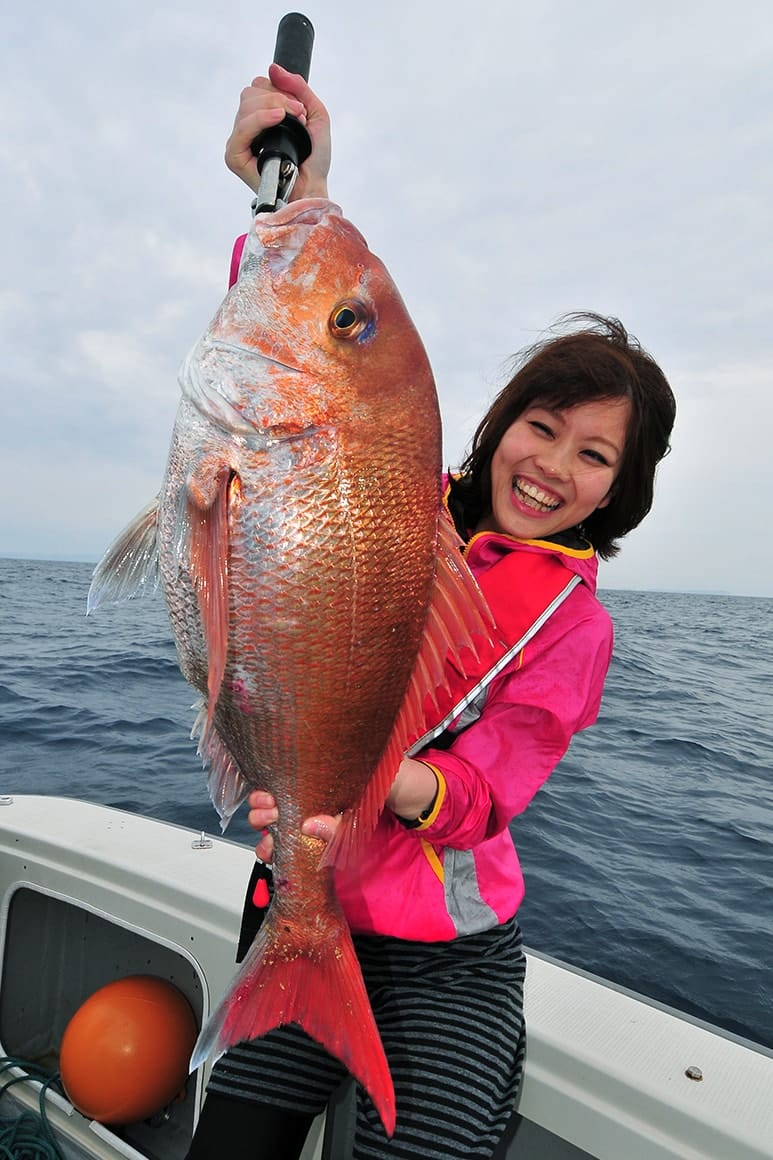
[187,465,231,723]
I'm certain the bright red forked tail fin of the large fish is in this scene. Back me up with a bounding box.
[190,916,396,1137]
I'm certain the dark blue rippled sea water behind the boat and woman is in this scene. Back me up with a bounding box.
[0,559,773,1049]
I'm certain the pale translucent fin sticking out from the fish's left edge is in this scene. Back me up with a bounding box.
[86,496,159,615]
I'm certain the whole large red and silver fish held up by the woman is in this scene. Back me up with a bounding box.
[89,200,487,1134]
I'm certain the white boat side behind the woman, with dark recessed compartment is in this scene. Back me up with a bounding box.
[0,796,773,1160]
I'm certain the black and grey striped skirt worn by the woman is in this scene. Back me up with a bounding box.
[208,919,526,1160]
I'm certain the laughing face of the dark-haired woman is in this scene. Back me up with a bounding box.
[476,398,630,539]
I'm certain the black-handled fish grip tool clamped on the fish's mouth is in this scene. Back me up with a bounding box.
[251,12,315,213]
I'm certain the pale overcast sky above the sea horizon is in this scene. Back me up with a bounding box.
[0,0,773,596]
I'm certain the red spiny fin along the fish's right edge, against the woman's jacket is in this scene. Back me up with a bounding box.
[323,507,494,867]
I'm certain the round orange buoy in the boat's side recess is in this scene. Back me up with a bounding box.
[59,974,196,1124]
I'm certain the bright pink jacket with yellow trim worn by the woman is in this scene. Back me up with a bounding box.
[335,532,613,942]
